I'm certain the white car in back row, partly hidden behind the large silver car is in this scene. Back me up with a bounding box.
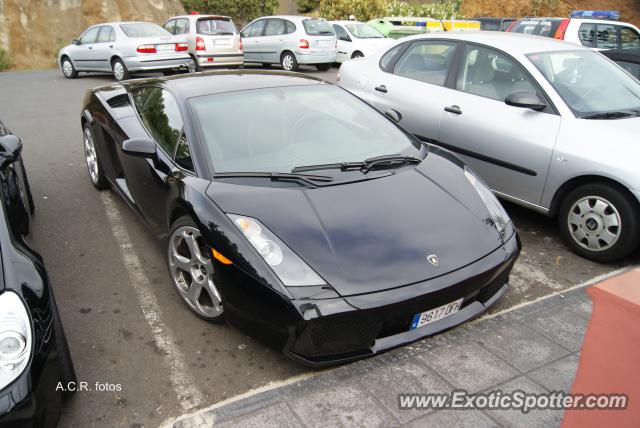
[330,21,393,62]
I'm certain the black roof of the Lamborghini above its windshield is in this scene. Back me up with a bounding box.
[124,70,328,98]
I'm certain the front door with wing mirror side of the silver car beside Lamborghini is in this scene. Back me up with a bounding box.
[439,44,561,204]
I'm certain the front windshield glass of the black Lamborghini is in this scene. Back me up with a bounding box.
[189,85,421,173]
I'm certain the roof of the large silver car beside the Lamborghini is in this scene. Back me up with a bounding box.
[410,31,589,55]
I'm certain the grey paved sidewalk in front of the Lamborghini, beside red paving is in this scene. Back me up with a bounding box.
[173,288,591,428]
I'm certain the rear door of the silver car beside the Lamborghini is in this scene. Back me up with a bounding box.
[371,40,458,140]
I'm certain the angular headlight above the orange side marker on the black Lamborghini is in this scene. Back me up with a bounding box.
[227,214,326,286]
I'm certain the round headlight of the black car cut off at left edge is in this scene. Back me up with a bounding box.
[0,291,31,389]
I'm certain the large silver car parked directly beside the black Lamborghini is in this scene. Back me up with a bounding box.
[339,32,640,262]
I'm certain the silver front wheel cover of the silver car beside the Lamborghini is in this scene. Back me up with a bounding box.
[567,196,622,251]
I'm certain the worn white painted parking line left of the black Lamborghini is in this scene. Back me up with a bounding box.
[100,192,204,411]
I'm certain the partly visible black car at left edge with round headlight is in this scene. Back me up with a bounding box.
[0,123,76,427]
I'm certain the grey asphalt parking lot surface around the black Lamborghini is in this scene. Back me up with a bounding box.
[0,65,638,427]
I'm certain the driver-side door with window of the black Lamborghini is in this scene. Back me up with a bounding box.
[121,86,184,234]
